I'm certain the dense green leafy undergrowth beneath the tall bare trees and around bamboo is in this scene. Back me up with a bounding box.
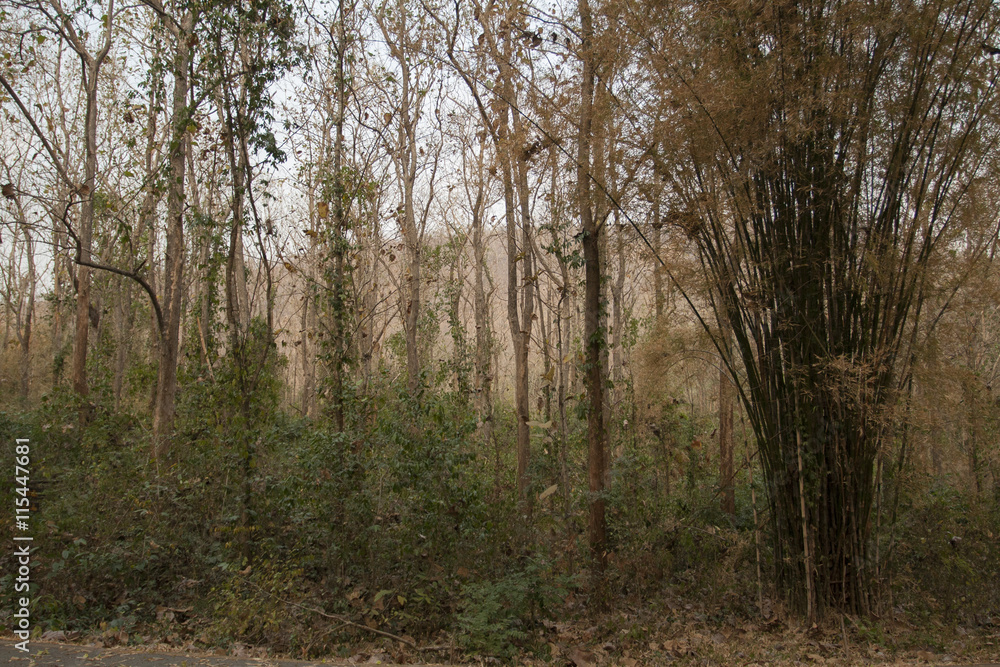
[0,380,1000,661]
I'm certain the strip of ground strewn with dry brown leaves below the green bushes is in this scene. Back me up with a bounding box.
[0,612,1000,667]
